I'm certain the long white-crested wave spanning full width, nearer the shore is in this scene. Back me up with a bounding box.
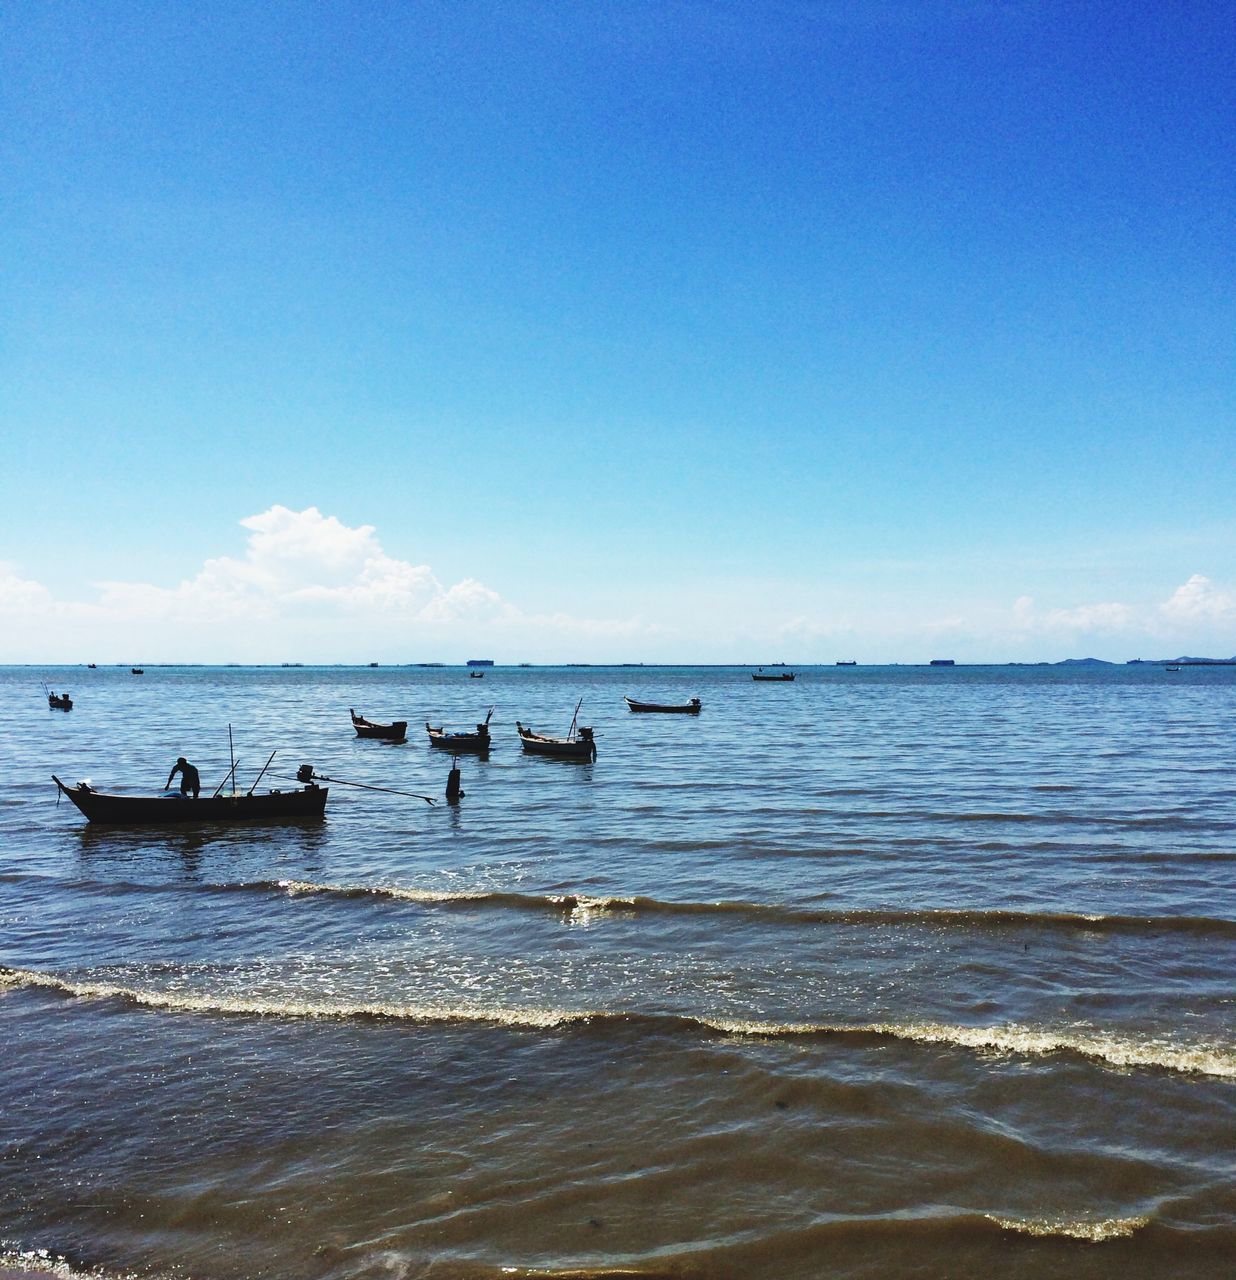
[0,966,1236,1080]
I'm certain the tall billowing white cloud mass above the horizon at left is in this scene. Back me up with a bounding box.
[0,506,655,662]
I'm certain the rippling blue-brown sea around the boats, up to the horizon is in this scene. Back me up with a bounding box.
[0,663,1236,1280]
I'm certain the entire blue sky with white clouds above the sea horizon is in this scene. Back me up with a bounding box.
[0,0,1236,662]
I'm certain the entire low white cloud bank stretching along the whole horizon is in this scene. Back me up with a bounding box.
[0,504,1236,662]
